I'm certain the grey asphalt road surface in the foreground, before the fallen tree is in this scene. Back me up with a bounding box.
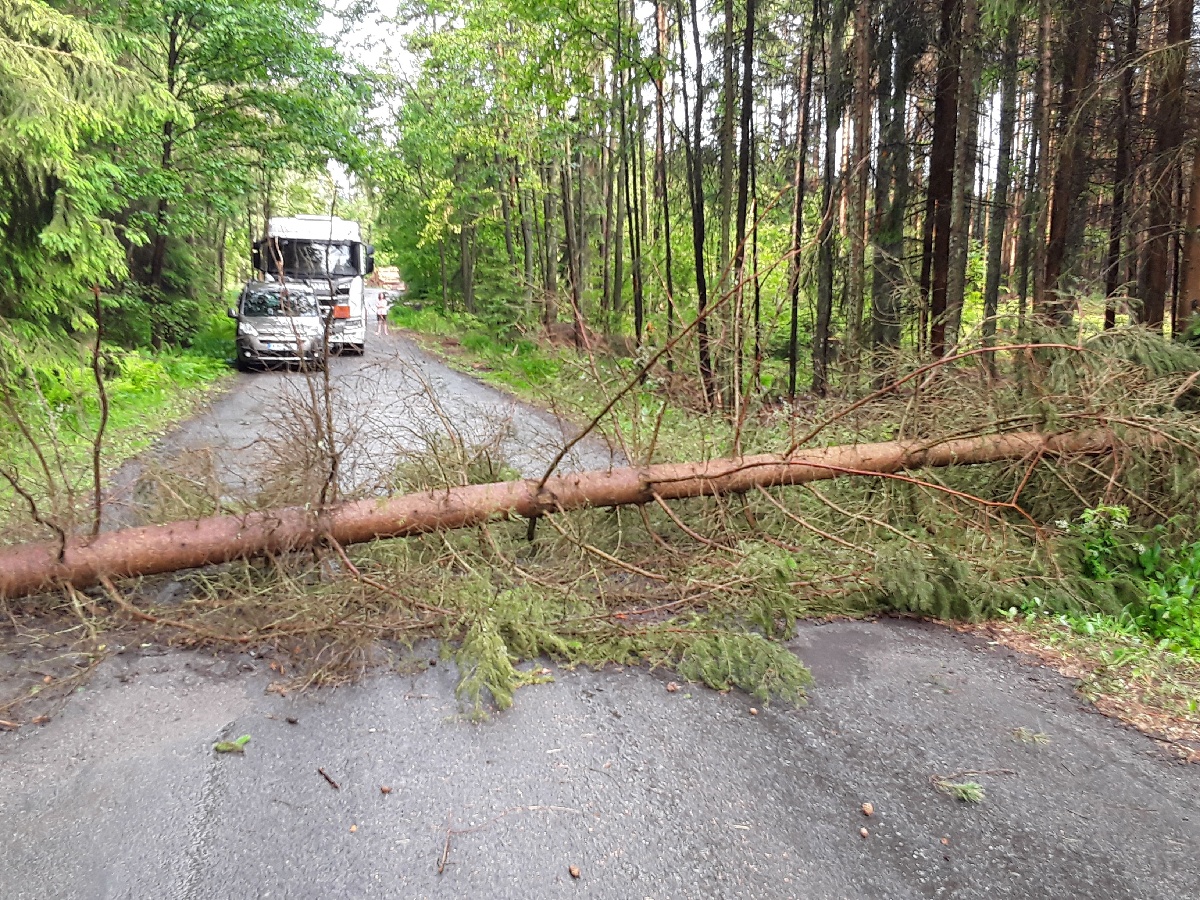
[0,338,1200,900]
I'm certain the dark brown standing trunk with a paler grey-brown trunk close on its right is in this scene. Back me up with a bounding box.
[920,0,962,356]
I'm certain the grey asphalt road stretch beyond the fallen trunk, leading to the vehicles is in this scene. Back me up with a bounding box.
[106,335,624,527]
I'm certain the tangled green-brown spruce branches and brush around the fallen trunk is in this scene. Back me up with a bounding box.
[0,330,1200,748]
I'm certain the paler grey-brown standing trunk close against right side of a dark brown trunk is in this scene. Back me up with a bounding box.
[944,0,980,352]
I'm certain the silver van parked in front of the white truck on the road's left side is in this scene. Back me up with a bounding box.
[229,281,326,372]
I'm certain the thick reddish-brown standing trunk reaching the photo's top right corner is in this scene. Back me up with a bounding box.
[1142,0,1193,331]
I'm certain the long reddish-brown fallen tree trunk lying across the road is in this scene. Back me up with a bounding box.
[0,428,1115,599]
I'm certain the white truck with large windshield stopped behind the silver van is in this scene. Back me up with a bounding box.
[251,216,374,354]
